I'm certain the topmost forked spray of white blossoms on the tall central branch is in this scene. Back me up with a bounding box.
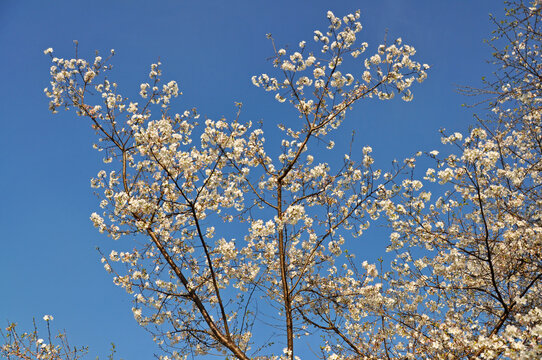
[252,11,429,126]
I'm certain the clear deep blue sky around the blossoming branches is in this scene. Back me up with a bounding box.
[0,0,503,359]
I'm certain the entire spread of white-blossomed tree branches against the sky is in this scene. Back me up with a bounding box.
[2,2,542,360]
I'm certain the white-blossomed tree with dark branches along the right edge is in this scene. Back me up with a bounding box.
[382,1,542,359]
